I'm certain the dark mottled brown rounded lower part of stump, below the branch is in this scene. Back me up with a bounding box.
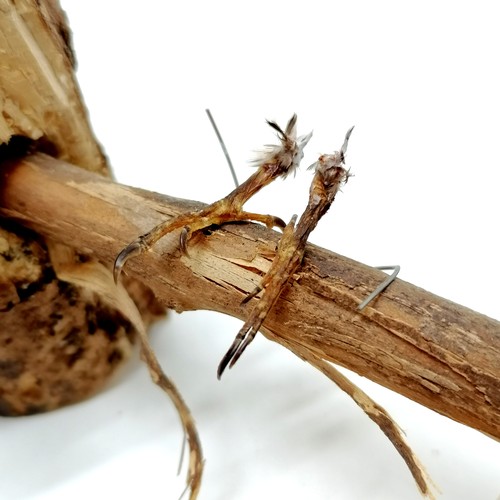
[0,222,147,415]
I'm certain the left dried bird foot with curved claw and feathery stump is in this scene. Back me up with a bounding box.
[113,115,312,282]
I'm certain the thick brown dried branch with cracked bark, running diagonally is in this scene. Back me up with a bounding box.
[0,154,500,439]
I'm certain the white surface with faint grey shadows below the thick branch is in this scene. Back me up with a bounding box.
[0,312,499,500]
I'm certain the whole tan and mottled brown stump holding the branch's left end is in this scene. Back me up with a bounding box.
[0,0,161,415]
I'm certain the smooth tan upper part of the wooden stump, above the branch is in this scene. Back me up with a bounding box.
[0,0,109,175]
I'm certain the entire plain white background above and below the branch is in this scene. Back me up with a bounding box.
[0,0,500,500]
